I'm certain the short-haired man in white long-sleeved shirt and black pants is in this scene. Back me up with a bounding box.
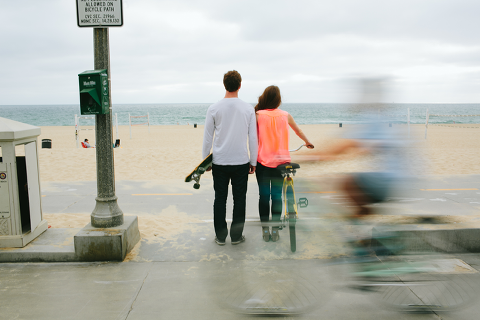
[202,70,258,246]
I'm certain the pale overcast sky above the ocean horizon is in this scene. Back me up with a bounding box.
[0,0,480,105]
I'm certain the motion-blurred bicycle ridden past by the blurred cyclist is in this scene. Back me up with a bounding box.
[220,198,480,316]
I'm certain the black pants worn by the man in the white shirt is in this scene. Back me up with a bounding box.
[212,163,249,241]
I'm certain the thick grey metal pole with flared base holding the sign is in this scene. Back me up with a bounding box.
[91,28,123,228]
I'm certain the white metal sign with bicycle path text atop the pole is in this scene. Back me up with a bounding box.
[77,0,123,28]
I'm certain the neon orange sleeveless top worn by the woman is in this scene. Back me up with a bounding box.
[257,108,290,168]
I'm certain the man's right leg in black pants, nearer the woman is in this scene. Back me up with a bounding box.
[230,163,249,241]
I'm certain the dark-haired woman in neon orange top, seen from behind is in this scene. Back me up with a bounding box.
[255,86,313,242]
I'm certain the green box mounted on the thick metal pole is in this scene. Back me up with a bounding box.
[78,69,110,115]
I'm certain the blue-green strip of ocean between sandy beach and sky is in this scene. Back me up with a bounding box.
[0,103,480,126]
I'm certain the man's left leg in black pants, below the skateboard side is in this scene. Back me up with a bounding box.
[212,164,230,241]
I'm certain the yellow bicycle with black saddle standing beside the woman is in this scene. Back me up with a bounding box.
[277,144,308,252]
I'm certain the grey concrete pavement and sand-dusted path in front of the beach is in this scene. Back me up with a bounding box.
[0,175,480,320]
